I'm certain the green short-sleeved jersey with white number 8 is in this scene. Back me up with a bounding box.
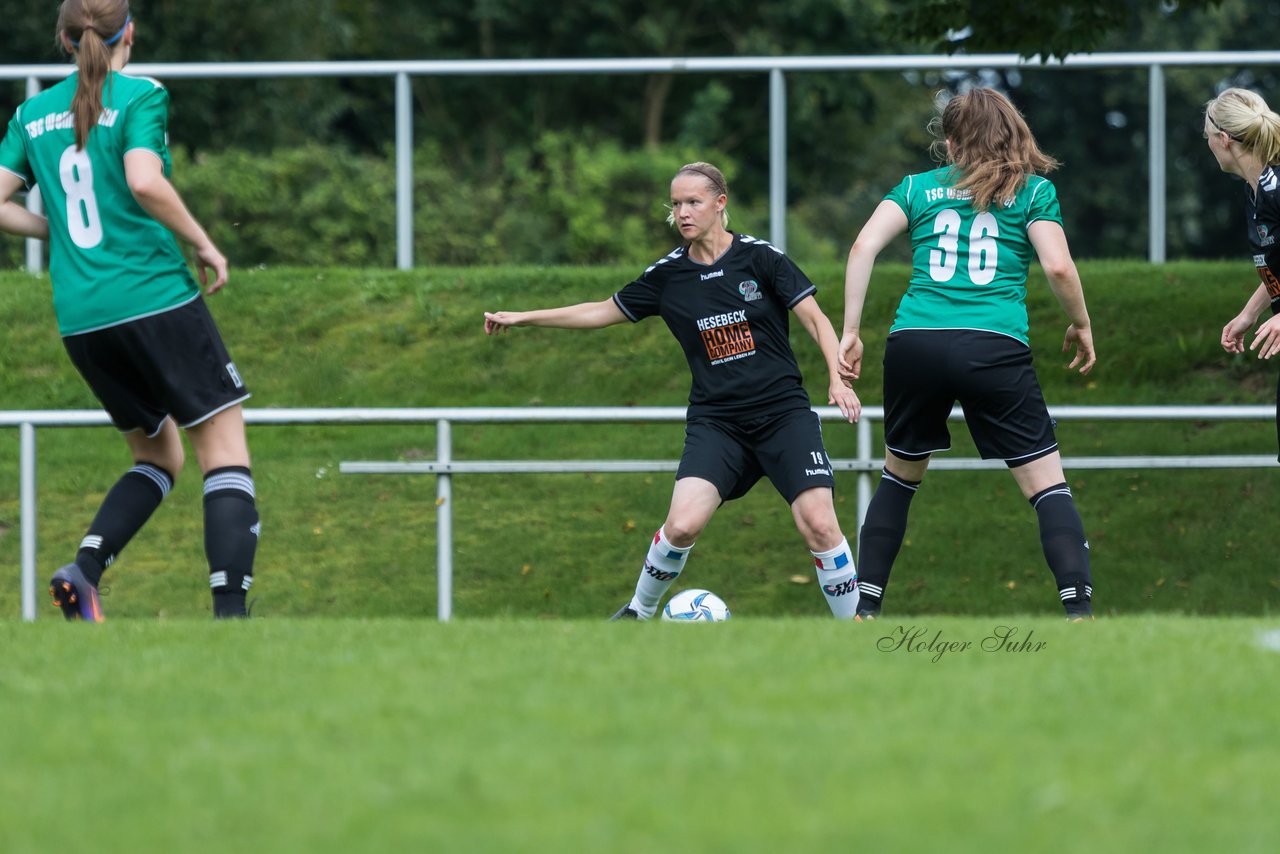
[0,72,200,335]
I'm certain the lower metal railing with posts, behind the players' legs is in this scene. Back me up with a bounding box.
[0,405,1276,621]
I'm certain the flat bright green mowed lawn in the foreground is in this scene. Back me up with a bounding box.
[0,617,1280,854]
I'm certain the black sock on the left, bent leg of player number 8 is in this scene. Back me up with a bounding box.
[76,462,173,586]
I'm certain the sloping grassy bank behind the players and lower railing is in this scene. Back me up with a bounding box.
[0,261,1280,618]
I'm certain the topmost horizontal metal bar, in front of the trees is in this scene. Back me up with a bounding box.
[0,50,1280,79]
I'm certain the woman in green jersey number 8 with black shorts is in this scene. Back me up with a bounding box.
[0,0,259,622]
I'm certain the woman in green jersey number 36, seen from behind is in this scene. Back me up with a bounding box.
[840,88,1096,620]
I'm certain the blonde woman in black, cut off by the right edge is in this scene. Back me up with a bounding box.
[1204,88,1280,460]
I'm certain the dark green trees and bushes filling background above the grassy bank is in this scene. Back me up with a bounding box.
[0,0,1280,262]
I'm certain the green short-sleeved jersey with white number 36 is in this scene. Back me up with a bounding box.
[884,166,1062,343]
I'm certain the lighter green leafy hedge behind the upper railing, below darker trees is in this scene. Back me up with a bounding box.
[0,133,885,269]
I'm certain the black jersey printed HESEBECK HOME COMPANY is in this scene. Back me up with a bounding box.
[613,234,817,417]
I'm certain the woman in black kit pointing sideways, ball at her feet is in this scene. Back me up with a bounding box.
[484,163,861,620]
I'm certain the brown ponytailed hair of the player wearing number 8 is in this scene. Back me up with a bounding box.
[54,0,129,149]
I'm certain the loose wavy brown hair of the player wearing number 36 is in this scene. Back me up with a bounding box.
[929,87,1059,210]
